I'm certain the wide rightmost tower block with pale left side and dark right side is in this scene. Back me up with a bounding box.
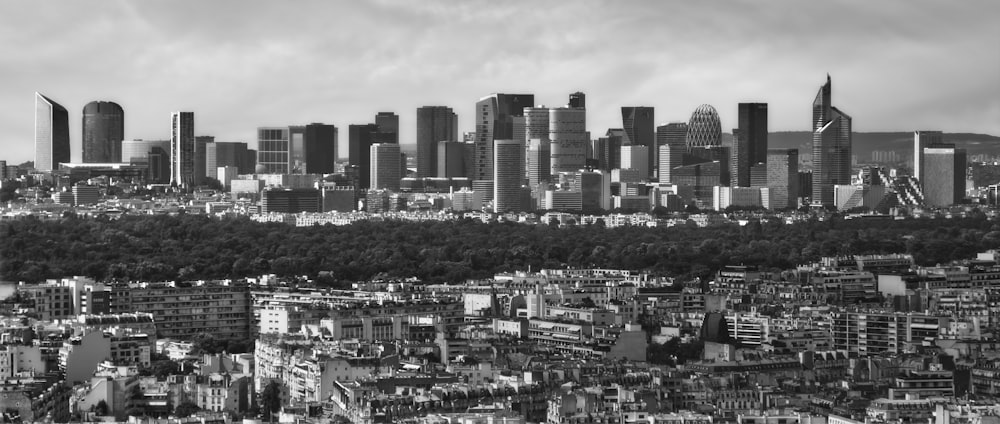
[920,144,968,207]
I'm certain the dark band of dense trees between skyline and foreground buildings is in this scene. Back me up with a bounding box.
[0,214,1000,283]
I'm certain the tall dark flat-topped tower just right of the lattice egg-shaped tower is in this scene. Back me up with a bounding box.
[729,103,767,187]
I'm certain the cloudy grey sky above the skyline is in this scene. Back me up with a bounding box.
[0,0,1000,164]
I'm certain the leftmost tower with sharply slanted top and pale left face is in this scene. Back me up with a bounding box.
[35,93,70,171]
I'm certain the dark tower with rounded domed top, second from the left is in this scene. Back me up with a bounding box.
[83,102,125,163]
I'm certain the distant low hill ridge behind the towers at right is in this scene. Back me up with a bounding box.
[767,131,1000,160]
